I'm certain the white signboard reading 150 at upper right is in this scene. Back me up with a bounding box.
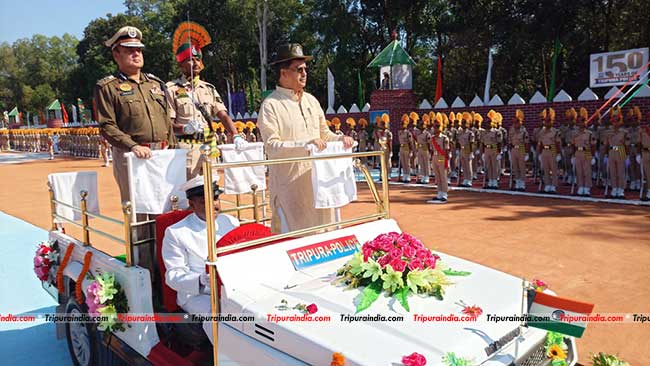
[589,47,649,88]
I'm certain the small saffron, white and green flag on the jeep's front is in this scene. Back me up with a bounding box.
[528,292,594,338]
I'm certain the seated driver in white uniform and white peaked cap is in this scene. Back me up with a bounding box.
[162,175,239,342]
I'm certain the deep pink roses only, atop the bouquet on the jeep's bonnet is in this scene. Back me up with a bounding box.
[361,232,440,272]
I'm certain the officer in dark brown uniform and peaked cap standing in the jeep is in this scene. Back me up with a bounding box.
[94,26,176,201]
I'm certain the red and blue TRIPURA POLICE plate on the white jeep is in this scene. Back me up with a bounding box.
[287,235,359,270]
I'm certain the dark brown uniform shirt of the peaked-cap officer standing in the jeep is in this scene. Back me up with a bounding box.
[94,73,176,150]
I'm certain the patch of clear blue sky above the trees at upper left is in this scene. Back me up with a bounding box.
[0,0,125,43]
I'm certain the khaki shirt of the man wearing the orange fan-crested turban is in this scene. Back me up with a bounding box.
[167,76,226,128]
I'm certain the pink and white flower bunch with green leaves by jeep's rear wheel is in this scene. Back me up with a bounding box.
[86,272,131,332]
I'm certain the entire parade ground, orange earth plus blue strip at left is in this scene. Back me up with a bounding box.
[0,153,650,366]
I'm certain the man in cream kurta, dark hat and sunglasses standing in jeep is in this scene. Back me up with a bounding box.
[257,43,354,233]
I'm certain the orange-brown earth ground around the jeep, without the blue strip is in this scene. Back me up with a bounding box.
[0,153,650,365]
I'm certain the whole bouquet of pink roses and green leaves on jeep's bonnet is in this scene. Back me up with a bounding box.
[334,232,470,313]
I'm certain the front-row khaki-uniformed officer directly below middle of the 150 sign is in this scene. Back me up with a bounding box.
[605,107,630,199]
